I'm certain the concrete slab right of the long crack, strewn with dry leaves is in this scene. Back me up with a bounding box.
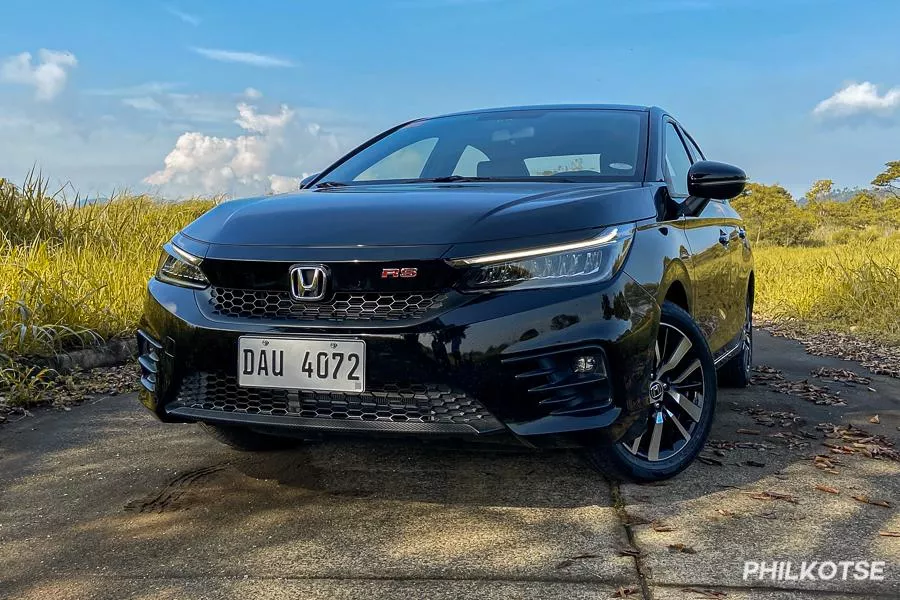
[621,336,900,599]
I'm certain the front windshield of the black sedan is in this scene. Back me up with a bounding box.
[318,109,647,185]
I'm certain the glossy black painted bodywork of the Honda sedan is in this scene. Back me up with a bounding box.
[142,106,753,445]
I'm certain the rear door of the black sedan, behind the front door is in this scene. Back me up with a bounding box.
[678,124,752,349]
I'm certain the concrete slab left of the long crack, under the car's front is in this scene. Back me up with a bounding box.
[0,397,637,597]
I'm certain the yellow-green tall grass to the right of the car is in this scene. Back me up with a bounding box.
[754,235,900,342]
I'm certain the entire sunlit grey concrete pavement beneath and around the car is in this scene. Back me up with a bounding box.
[0,333,900,599]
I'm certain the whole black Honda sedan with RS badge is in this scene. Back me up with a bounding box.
[138,105,754,481]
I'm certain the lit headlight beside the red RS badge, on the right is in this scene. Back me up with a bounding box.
[449,224,634,291]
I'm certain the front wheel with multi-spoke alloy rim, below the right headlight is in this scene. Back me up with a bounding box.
[587,302,717,482]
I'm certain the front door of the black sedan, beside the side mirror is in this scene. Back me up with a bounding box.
[663,119,733,354]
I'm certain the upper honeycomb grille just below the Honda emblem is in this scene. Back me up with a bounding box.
[209,287,447,321]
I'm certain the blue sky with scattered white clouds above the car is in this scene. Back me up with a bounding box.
[0,0,900,198]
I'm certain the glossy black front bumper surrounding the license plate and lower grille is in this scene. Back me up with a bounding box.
[138,273,659,445]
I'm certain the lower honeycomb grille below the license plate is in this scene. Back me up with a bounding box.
[169,372,502,432]
